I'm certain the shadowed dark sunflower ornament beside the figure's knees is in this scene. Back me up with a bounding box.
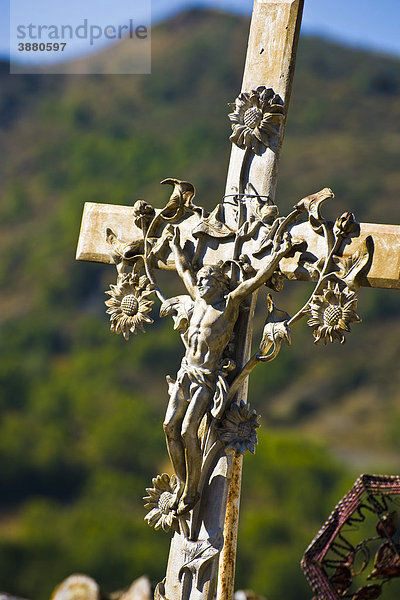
[218,400,260,456]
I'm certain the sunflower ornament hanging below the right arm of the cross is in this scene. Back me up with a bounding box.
[307,281,361,344]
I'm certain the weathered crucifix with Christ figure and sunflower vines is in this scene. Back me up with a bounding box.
[77,0,400,600]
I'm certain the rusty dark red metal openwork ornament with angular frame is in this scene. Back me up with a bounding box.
[301,475,400,600]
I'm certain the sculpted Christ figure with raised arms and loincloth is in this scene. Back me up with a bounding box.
[164,227,291,515]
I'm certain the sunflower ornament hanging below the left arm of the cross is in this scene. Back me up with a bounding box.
[105,274,154,340]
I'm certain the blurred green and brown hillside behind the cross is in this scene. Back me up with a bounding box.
[0,11,400,600]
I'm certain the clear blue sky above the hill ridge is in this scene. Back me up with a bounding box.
[0,0,400,66]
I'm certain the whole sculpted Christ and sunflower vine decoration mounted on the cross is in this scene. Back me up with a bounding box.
[98,74,373,598]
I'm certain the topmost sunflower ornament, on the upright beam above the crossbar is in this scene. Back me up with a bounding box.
[229,85,284,154]
